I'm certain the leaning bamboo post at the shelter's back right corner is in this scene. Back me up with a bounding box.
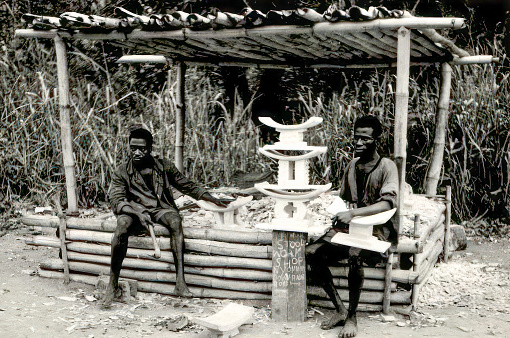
[425,62,452,195]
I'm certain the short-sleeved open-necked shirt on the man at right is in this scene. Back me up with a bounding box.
[340,157,398,242]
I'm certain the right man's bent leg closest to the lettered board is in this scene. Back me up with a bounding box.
[305,243,347,330]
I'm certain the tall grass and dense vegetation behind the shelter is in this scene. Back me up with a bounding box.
[0,0,510,231]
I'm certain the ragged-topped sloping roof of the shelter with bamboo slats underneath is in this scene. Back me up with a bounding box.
[16,6,494,67]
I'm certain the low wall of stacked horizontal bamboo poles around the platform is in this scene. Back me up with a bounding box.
[23,193,449,311]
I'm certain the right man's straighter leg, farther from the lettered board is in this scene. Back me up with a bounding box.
[338,255,365,338]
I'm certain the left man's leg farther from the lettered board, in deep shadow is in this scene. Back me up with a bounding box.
[101,215,133,309]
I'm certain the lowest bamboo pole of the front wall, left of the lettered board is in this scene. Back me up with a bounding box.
[38,269,271,300]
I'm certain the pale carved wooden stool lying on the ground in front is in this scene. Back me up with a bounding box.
[191,303,255,338]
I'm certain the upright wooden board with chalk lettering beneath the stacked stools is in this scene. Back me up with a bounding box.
[271,230,307,322]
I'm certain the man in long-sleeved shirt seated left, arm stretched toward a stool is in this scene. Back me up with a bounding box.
[102,127,227,308]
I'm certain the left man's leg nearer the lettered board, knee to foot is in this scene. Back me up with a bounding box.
[158,210,193,297]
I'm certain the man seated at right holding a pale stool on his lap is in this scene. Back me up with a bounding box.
[306,116,398,337]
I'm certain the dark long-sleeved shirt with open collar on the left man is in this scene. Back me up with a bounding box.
[108,157,206,215]
